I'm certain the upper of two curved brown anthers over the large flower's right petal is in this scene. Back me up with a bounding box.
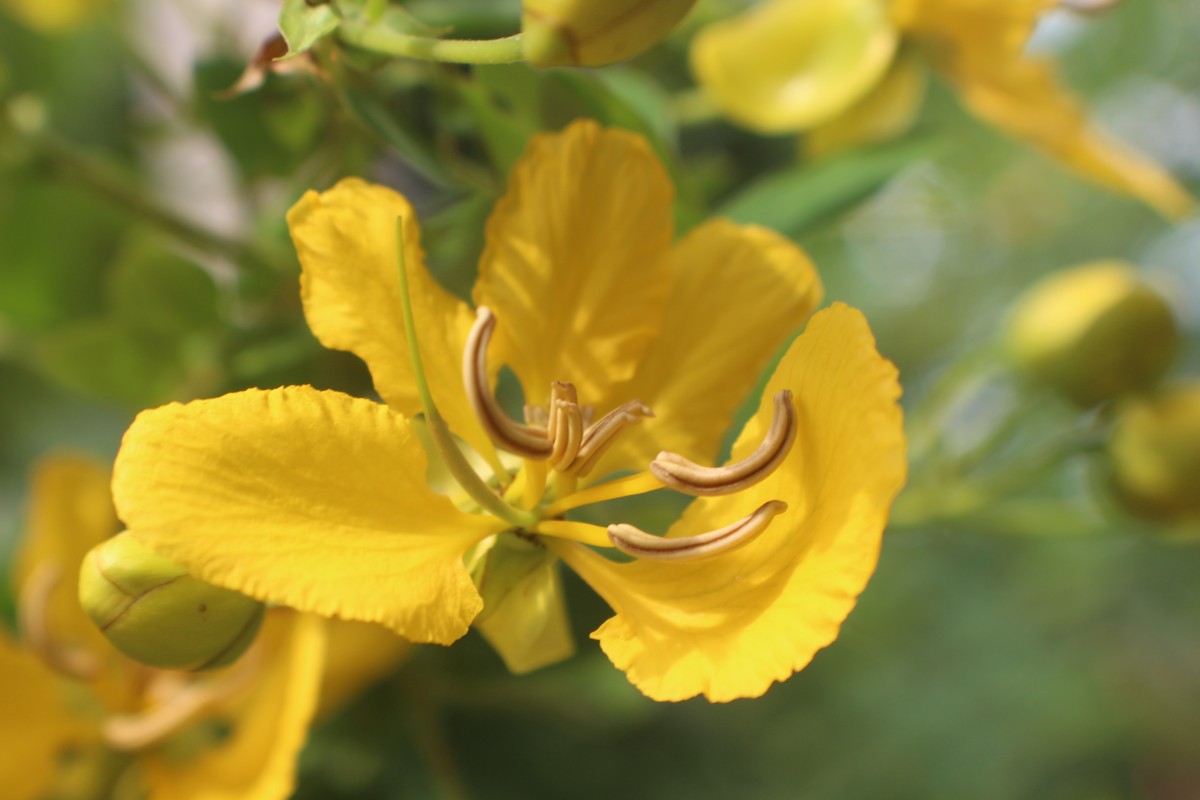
[650,389,797,497]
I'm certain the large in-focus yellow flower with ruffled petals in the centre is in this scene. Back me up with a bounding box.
[114,122,905,700]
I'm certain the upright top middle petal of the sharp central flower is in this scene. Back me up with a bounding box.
[474,121,673,414]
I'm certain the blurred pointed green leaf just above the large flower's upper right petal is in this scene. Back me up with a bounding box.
[718,139,936,236]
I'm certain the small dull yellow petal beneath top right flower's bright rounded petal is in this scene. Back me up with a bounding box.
[804,50,926,157]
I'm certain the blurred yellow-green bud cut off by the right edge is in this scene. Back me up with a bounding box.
[1109,383,1200,522]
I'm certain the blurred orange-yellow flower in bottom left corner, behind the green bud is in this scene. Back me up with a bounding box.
[0,456,325,800]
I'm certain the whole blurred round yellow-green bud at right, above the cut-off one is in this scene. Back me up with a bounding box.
[1007,261,1180,408]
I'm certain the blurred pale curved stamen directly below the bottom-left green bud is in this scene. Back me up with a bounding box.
[102,648,263,752]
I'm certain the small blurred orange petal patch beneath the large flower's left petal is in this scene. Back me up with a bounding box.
[317,619,413,717]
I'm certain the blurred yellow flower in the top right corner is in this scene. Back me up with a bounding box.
[691,0,1195,218]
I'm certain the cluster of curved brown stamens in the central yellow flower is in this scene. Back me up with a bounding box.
[462,307,797,560]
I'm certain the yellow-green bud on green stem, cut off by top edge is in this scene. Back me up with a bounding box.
[521,0,696,67]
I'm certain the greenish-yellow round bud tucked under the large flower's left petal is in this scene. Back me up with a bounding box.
[79,533,264,669]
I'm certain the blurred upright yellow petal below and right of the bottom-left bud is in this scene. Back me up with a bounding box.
[142,608,325,800]
